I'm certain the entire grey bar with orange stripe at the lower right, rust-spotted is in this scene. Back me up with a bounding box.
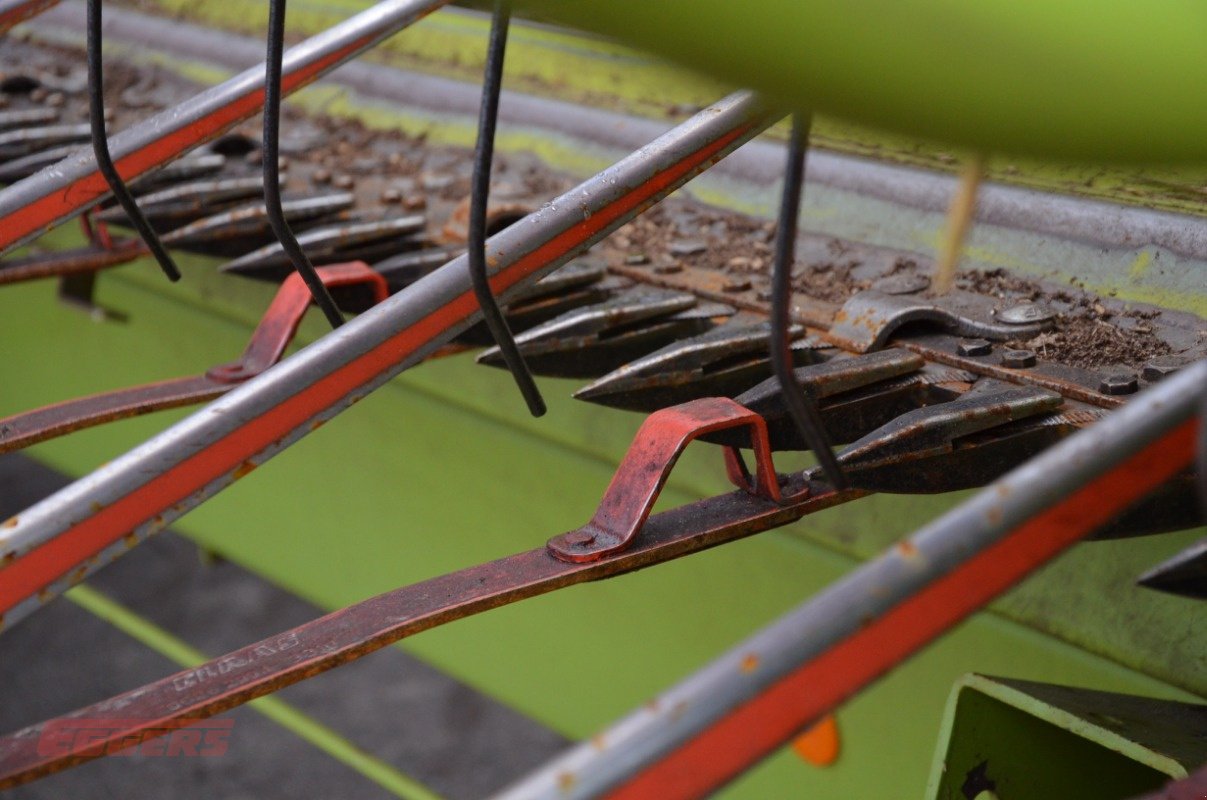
[496,361,1207,800]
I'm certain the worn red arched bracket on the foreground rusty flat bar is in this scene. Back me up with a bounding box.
[547,397,780,563]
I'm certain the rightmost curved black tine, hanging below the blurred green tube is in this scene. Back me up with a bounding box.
[771,112,849,490]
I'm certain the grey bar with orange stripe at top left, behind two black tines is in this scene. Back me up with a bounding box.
[0,0,449,255]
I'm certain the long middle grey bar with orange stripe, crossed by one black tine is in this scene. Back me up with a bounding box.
[0,92,775,624]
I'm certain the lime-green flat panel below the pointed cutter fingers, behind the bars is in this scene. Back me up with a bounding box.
[0,248,1201,799]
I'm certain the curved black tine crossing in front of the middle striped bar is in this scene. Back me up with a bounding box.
[466,0,546,416]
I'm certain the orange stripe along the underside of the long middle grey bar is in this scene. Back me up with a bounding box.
[0,124,753,615]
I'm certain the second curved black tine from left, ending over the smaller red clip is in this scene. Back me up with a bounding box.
[261,0,344,328]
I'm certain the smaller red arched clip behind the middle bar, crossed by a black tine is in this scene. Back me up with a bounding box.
[205,261,390,384]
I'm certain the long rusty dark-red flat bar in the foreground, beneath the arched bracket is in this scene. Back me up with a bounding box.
[0,475,861,789]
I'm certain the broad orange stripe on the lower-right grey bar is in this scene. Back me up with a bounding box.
[607,419,1197,800]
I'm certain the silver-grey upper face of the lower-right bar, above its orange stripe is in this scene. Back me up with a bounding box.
[495,361,1207,800]
